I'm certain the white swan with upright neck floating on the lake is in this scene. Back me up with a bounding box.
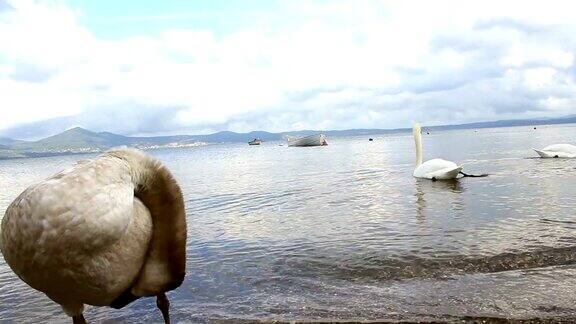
[412,123,462,180]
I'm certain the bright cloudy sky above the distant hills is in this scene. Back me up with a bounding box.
[0,0,576,139]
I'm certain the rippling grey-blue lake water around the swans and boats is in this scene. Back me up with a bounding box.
[0,125,576,322]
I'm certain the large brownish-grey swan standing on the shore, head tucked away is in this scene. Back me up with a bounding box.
[0,149,186,323]
